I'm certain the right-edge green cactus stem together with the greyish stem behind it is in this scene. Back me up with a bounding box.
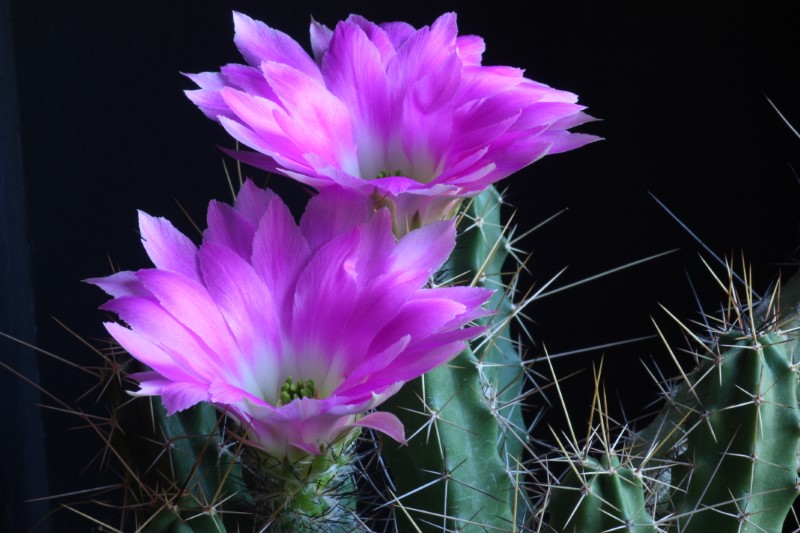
[632,264,800,533]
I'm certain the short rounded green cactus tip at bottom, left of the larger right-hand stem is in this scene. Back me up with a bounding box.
[549,454,657,533]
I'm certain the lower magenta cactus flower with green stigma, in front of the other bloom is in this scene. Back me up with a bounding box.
[89,181,490,456]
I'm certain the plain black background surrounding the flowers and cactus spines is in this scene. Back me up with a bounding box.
[0,0,800,531]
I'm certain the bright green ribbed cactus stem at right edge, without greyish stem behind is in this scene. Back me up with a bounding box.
[677,333,800,533]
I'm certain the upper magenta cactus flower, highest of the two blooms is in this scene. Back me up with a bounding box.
[187,13,597,233]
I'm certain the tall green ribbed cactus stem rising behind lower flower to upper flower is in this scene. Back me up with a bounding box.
[383,189,527,531]
